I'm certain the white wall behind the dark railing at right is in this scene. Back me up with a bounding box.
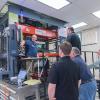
[81,27,100,64]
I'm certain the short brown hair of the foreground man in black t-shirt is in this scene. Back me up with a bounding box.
[60,41,72,55]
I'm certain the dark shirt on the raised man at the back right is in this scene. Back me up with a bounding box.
[67,33,81,51]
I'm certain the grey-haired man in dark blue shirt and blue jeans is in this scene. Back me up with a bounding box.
[70,47,97,100]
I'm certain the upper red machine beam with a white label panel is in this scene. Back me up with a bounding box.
[16,23,57,39]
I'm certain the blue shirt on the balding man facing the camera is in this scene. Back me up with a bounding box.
[25,40,37,57]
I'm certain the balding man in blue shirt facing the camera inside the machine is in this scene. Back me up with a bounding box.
[21,35,37,57]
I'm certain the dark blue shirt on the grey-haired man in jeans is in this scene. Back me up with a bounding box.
[72,55,93,81]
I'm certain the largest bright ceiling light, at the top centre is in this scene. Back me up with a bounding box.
[38,0,70,9]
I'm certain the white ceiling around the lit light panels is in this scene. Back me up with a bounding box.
[0,0,100,31]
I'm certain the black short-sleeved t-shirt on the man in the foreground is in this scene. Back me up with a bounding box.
[48,56,80,100]
